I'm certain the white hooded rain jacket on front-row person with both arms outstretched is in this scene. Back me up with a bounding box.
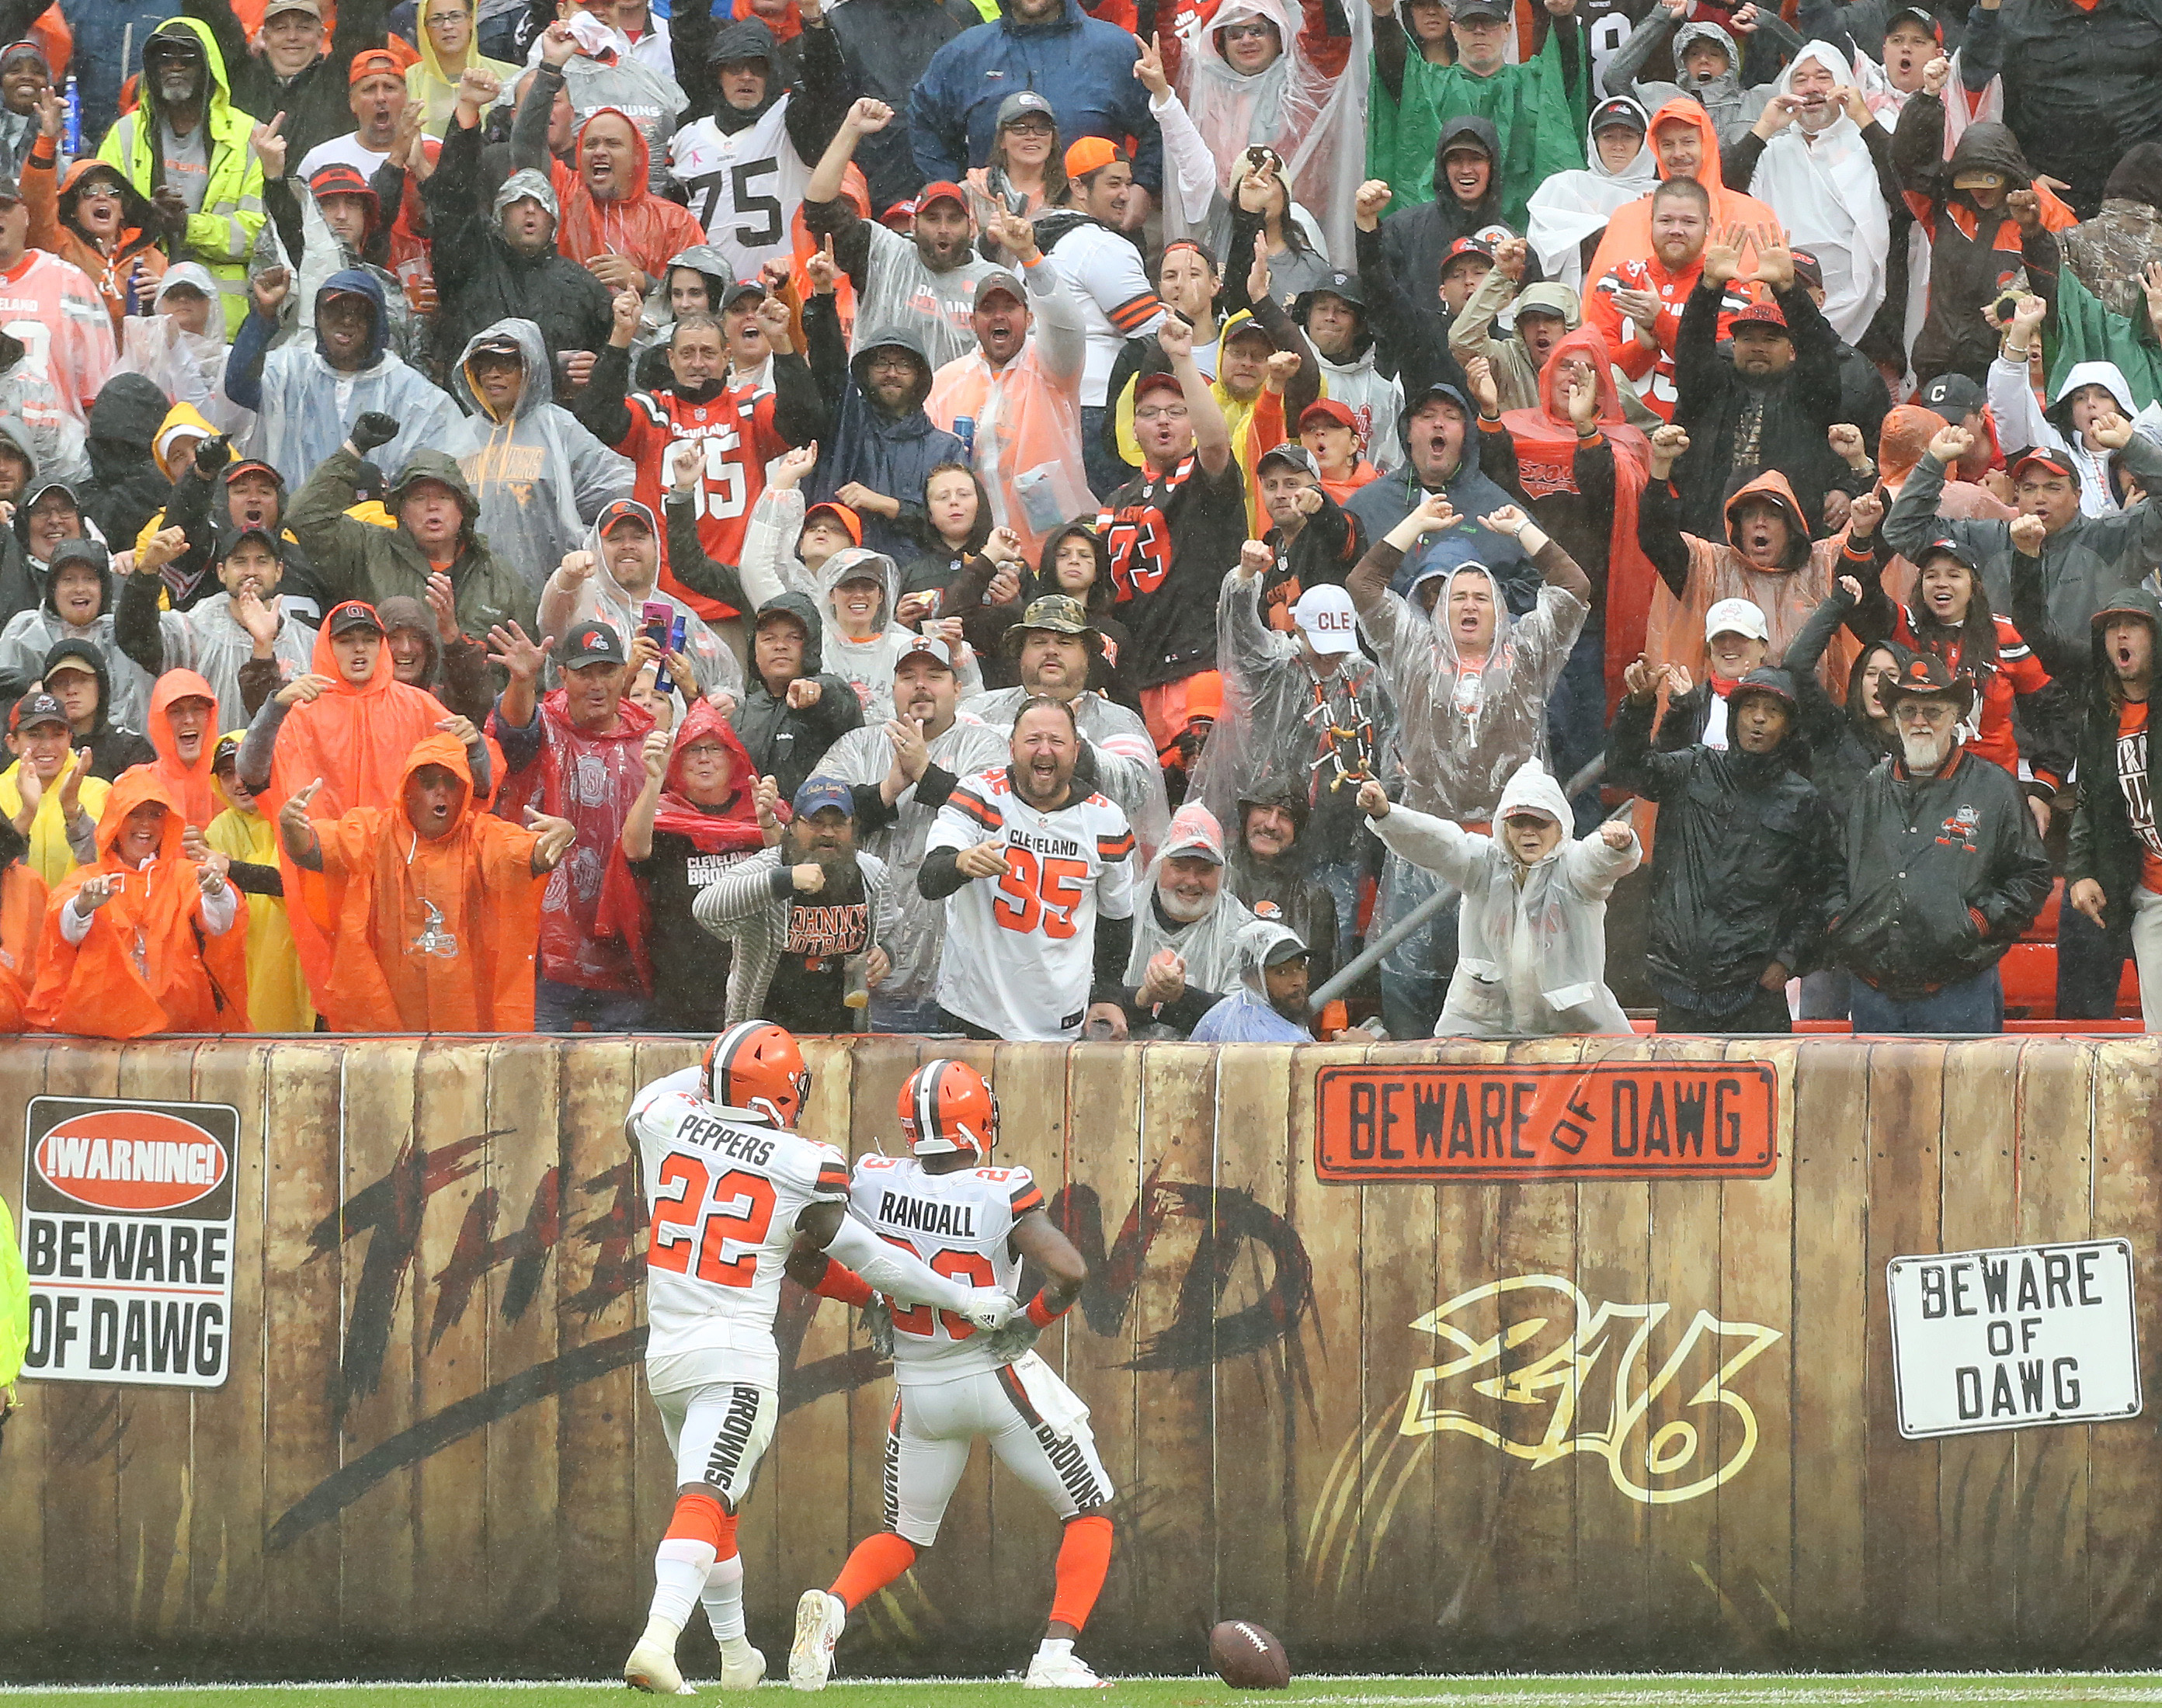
[1373,759,1643,1038]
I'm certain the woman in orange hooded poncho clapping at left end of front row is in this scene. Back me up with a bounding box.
[28,765,249,1038]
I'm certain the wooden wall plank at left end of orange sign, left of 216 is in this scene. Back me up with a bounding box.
[1277,1044,1375,1665]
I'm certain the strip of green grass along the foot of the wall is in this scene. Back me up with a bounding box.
[12,1673,2162,1708]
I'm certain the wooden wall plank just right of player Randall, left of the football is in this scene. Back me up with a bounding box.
[1131,1044,1215,1650]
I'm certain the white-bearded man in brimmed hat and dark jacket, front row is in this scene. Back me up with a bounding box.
[1831,653,2049,1033]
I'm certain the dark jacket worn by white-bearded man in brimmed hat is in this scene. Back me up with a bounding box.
[1831,748,2049,999]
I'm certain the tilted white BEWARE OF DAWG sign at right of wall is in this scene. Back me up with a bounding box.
[1886,1239,2140,1438]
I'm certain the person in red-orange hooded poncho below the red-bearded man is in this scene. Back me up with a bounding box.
[1479,327,1658,717]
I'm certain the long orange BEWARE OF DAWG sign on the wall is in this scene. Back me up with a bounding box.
[1315,1061,1779,1185]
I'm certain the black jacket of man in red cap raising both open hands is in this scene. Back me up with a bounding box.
[1674,283,1853,540]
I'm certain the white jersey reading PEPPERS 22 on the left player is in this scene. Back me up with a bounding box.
[629,1068,847,1390]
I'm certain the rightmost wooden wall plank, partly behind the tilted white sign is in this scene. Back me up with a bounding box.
[2084,1038,2162,1665]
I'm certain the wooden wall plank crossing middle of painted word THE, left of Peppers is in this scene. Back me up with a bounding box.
[484,1038,579,1639]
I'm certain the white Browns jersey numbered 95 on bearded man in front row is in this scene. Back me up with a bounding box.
[923,765,1133,1040]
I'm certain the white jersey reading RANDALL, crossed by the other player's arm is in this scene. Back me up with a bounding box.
[850,1154,1045,1388]
